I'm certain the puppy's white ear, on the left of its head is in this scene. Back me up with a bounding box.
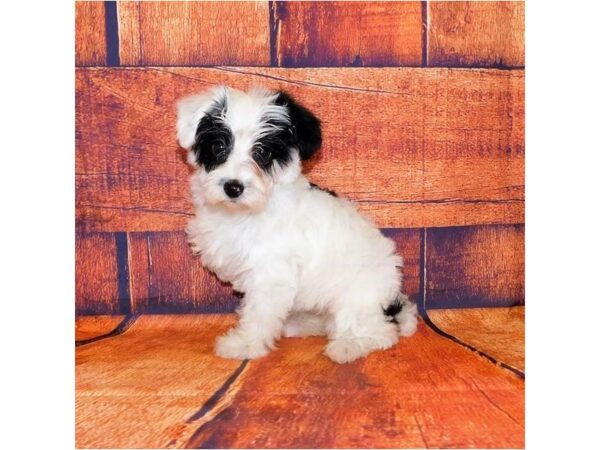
[177,86,227,150]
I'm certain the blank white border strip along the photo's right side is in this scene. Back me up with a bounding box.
[525,1,600,449]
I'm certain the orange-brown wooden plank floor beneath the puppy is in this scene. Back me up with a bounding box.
[76,309,525,448]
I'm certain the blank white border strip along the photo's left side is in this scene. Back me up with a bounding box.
[0,1,75,449]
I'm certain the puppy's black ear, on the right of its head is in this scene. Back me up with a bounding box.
[275,91,322,160]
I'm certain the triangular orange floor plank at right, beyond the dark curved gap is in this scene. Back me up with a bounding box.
[428,306,525,371]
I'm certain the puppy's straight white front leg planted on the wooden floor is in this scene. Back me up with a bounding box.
[215,283,296,359]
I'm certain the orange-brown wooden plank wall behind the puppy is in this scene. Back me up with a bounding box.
[75,1,525,314]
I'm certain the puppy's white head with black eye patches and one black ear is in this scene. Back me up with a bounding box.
[177,87,321,211]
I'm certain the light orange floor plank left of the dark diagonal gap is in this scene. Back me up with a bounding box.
[75,315,240,448]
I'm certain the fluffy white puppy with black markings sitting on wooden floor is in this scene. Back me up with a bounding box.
[177,87,417,363]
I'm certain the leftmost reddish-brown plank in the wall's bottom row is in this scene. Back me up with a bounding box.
[75,232,119,314]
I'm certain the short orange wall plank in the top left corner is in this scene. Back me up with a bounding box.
[75,1,106,66]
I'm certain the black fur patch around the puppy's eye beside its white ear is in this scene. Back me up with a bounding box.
[192,97,233,172]
